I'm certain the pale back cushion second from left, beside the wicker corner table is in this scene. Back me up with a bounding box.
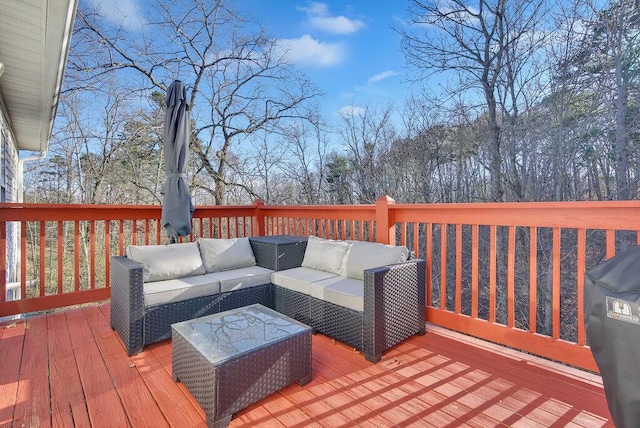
[198,238,256,272]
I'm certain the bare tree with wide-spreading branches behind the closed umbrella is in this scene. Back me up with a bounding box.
[69,0,318,204]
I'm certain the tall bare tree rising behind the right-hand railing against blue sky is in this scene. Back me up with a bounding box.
[400,0,544,201]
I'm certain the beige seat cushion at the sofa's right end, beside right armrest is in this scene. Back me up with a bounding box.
[309,276,364,312]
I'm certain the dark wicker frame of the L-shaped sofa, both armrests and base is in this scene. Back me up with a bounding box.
[111,244,426,362]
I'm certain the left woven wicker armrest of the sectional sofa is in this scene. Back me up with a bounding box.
[111,256,144,356]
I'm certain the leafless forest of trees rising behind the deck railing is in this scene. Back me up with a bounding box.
[25,0,640,205]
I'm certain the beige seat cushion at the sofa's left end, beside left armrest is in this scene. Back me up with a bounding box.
[143,275,220,307]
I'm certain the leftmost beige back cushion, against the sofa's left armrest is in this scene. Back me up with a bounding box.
[127,242,206,282]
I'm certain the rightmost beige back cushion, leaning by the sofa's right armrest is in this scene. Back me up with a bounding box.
[341,241,409,280]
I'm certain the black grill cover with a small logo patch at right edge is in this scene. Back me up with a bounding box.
[584,247,640,428]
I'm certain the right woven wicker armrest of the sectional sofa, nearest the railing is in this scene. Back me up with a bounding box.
[363,259,426,362]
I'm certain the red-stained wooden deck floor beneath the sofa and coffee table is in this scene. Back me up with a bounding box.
[0,304,613,428]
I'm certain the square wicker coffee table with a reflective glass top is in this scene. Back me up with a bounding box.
[171,304,311,427]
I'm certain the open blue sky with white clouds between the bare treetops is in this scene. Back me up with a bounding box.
[89,0,416,120]
